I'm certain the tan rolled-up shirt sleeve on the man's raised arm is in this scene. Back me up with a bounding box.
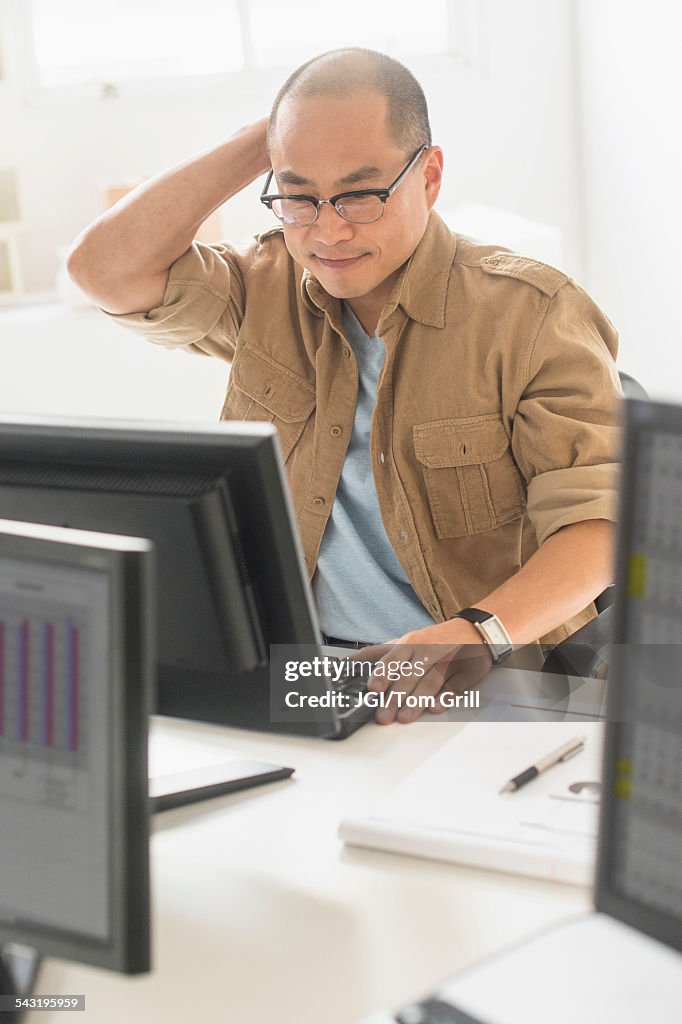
[101,242,245,361]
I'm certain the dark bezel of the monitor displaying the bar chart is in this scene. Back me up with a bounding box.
[0,520,156,974]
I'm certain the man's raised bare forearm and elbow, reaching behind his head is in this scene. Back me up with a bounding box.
[69,120,269,312]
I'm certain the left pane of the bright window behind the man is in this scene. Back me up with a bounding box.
[31,0,244,87]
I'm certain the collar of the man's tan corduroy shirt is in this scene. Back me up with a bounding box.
[301,211,457,328]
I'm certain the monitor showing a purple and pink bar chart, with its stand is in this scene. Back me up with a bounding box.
[0,520,156,1020]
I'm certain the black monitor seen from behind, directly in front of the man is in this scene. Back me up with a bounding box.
[0,416,331,735]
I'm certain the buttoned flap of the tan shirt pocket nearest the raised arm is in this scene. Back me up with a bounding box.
[231,349,315,423]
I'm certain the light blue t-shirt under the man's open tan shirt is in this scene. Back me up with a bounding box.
[312,302,433,642]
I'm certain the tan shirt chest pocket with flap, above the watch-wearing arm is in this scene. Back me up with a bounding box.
[413,414,525,540]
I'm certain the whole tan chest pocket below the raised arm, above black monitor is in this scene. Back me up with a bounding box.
[221,349,315,462]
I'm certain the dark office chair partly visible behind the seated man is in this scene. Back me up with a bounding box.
[543,372,648,678]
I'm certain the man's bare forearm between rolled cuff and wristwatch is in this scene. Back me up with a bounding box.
[477,519,614,644]
